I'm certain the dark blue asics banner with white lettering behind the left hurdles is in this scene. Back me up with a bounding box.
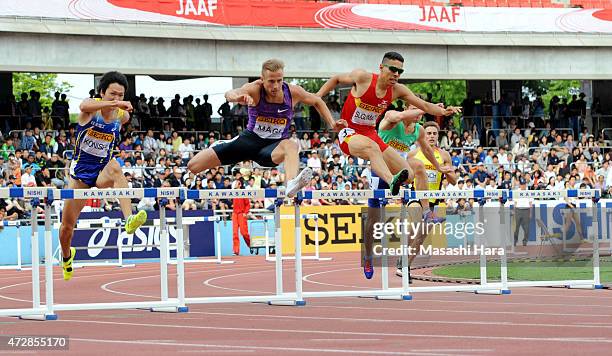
[72,210,215,261]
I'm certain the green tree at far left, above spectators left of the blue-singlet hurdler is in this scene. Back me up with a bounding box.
[13,73,72,109]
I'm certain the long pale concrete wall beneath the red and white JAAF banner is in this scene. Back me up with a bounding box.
[0,32,612,80]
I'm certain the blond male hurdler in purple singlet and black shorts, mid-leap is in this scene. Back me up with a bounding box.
[187,59,346,197]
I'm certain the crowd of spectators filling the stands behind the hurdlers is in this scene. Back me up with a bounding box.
[0,91,612,219]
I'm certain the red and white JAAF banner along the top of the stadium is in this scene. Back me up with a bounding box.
[0,0,612,33]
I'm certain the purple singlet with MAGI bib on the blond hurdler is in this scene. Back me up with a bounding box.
[247,82,293,139]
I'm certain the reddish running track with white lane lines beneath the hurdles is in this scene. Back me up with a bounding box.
[0,254,612,356]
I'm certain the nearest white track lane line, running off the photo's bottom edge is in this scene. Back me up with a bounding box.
[70,337,448,356]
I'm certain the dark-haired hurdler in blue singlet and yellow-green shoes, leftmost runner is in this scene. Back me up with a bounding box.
[59,72,147,280]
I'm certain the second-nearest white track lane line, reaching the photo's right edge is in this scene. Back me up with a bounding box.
[57,319,612,344]
